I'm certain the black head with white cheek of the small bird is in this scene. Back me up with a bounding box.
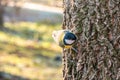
[63,31,77,45]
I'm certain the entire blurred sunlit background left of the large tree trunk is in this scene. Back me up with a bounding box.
[0,0,62,80]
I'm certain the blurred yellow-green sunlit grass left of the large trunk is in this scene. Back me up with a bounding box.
[0,22,62,80]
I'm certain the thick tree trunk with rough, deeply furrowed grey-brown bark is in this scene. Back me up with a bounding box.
[63,0,120,80]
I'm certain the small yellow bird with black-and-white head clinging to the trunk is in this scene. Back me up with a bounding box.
[52,30,77,49]
